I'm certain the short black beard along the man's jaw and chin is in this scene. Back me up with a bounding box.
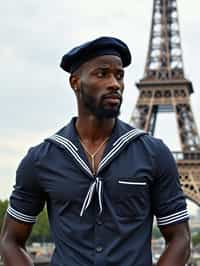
[80,86,121,120]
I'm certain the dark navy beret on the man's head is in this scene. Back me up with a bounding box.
[60,37,131,73]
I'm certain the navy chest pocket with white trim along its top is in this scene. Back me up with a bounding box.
[115,177,150,219]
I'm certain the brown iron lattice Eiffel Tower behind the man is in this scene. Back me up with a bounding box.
[130,0,200,206]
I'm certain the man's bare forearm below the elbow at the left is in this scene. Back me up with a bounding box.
[0,242,34,266]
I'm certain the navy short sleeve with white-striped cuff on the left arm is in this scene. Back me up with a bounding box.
[7,148,45,223]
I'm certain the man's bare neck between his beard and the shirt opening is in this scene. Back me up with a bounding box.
[76,116,116,142]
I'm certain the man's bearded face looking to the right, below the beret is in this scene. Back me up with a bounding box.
[78,55,124,119]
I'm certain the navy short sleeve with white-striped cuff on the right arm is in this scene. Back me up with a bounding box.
[152,140,189,226]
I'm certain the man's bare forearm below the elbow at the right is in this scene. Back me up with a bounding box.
[157,239,190,266]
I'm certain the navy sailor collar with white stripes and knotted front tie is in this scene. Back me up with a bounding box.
[46,117,147,216]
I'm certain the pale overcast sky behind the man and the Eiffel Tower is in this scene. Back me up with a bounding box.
[0,0,200,212]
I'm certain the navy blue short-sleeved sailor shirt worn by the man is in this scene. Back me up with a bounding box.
[7,118,188,266]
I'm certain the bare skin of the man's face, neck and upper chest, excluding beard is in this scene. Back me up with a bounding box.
[70,56,124,174]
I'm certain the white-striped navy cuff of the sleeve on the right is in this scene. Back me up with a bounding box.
[157,209,189,226]
